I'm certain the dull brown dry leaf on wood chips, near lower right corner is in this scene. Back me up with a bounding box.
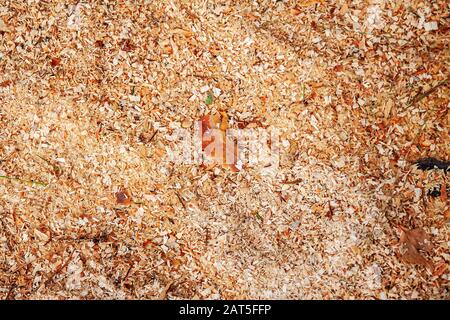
[399,226,433,269]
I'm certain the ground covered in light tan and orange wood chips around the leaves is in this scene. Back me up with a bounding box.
[0,0,450,299]
